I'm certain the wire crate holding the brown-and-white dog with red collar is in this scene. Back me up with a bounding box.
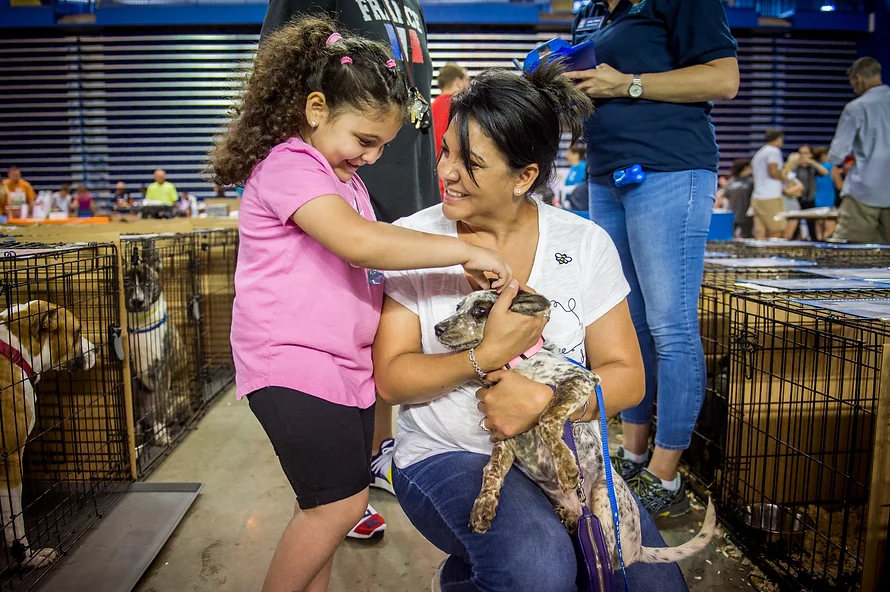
[0,241,131,592]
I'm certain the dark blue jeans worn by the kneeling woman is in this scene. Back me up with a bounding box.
[393,452,688,592]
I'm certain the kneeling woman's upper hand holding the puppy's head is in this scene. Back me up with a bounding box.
[475,280,550,372]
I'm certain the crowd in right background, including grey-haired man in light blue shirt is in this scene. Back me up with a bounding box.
[716,58,890,244]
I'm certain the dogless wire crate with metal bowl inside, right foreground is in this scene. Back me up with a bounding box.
[717,289,890,591]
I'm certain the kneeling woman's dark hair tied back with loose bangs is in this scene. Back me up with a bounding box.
[449,62,593,193]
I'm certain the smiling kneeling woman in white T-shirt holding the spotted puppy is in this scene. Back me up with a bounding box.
[374,62,686,592]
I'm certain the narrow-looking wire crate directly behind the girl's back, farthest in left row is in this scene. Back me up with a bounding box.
[194,228,238,405]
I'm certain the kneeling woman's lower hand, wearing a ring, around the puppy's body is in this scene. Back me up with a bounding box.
[476,370,553,440]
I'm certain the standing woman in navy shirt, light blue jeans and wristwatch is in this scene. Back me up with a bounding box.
[566,0,739,516]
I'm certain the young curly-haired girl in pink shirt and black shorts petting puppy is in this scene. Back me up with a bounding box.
[211,18,512,592]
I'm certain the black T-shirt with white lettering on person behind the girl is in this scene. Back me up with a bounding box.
[262,0,439,222]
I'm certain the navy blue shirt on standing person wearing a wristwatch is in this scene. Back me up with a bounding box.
[572,0,737,177]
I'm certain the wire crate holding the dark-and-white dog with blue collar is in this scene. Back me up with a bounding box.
[121,234,204,477]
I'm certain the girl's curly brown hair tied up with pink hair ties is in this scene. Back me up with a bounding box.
[209,17,408,185]
